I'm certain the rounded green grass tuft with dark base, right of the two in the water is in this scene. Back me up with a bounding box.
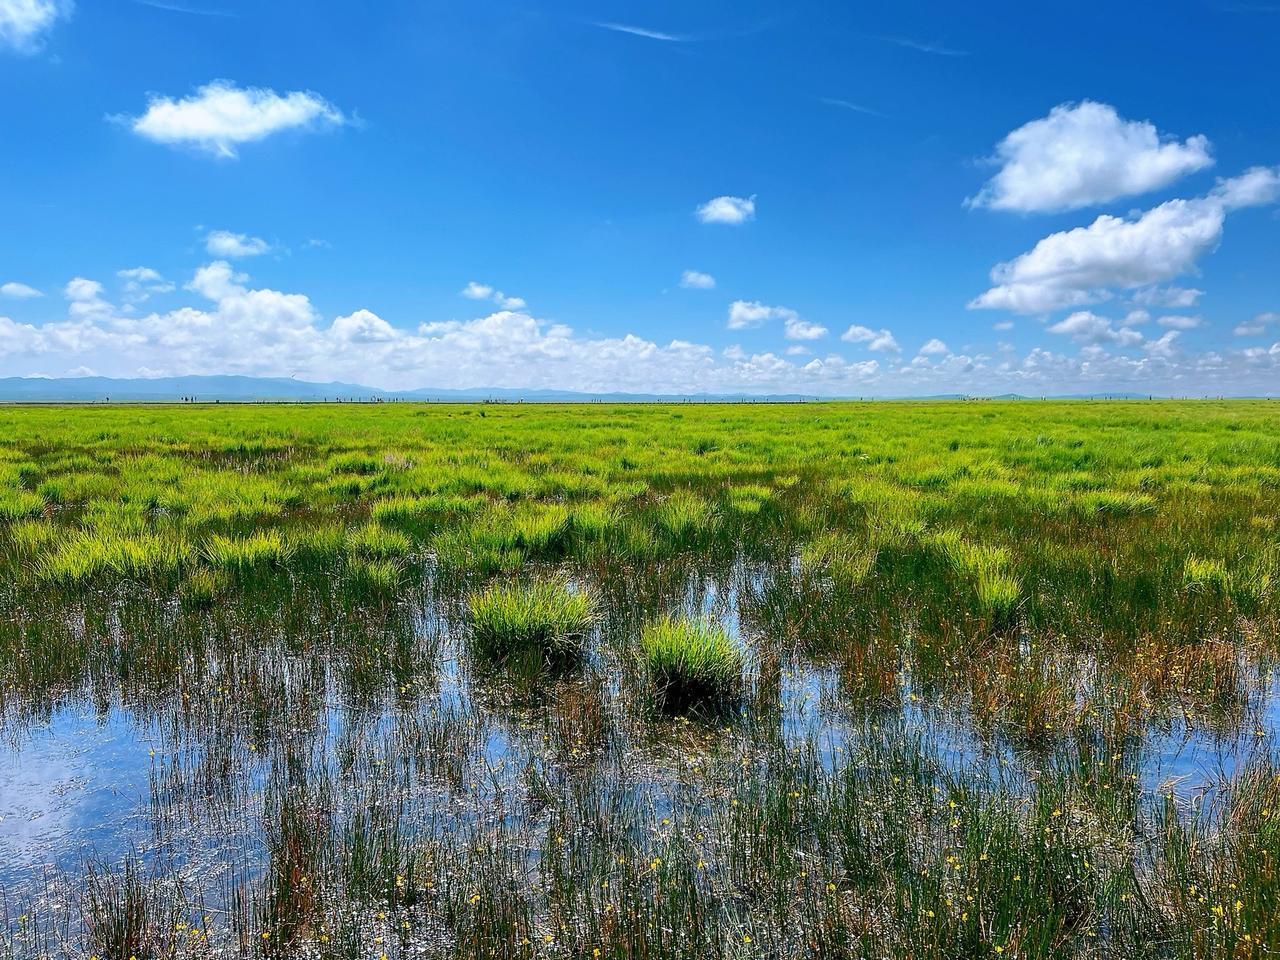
[640,617,744,709]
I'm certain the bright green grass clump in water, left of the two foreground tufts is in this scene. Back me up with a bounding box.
[470,580,595,662]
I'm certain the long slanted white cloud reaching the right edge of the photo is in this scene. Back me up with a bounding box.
[969,168,1280,314]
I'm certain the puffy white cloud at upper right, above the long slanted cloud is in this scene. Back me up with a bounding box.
[966,100,1213,212]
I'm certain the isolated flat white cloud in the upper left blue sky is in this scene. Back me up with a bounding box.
[123,81,348,157]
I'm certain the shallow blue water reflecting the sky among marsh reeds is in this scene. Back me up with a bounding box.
[0,564,1280,936]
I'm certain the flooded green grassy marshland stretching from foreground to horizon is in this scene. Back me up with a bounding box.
[0,401,1280,960]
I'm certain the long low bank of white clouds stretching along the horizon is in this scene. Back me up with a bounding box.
[0,261,1280,397]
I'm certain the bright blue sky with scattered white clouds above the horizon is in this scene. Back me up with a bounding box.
[0,0,1280,396]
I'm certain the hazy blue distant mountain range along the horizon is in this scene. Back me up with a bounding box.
[0,376,1198,403]
